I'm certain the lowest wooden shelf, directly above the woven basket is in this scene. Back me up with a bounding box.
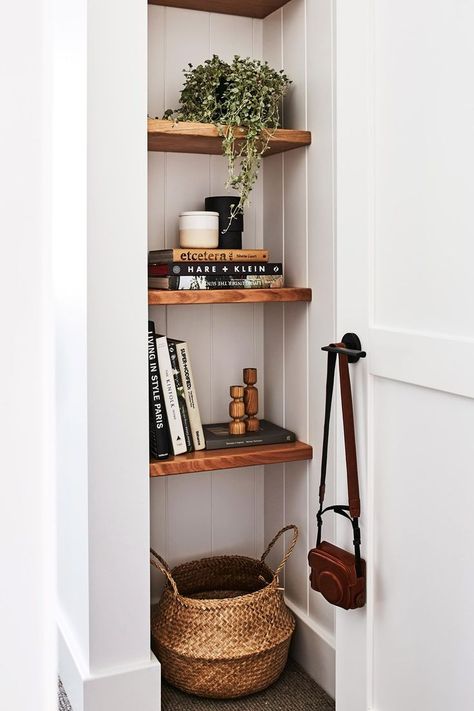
[150,442,313,477]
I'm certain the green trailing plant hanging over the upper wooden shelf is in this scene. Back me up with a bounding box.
[164,55,291,225]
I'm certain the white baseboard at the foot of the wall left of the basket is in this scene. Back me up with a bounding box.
[58,625,161,711]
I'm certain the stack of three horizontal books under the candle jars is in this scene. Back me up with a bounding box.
[148,249,284,290]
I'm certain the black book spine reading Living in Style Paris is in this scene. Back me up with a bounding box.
[148,321,170,459]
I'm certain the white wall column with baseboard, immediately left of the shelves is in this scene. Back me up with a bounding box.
[53,0,159,711]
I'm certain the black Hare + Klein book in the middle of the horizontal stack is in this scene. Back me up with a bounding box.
[148,262,283,277]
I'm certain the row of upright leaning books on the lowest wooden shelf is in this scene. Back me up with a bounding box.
[148,321,206,459]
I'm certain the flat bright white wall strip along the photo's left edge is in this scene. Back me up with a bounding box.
[0,0,56,711]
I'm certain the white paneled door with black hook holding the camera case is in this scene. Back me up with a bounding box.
[335,0,474,711]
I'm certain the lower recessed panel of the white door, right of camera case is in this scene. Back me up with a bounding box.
[373,378,474,711]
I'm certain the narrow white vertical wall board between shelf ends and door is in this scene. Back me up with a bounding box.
[306,0,336,633]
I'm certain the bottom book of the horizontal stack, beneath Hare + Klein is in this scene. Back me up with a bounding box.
[148,274,284,291]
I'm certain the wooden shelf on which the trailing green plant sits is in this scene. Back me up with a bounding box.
[148,119,311,156]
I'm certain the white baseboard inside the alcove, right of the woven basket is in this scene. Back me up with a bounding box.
[285,600,336,699]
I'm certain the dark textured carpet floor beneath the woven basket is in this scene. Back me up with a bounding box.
[59,661,335,711]
